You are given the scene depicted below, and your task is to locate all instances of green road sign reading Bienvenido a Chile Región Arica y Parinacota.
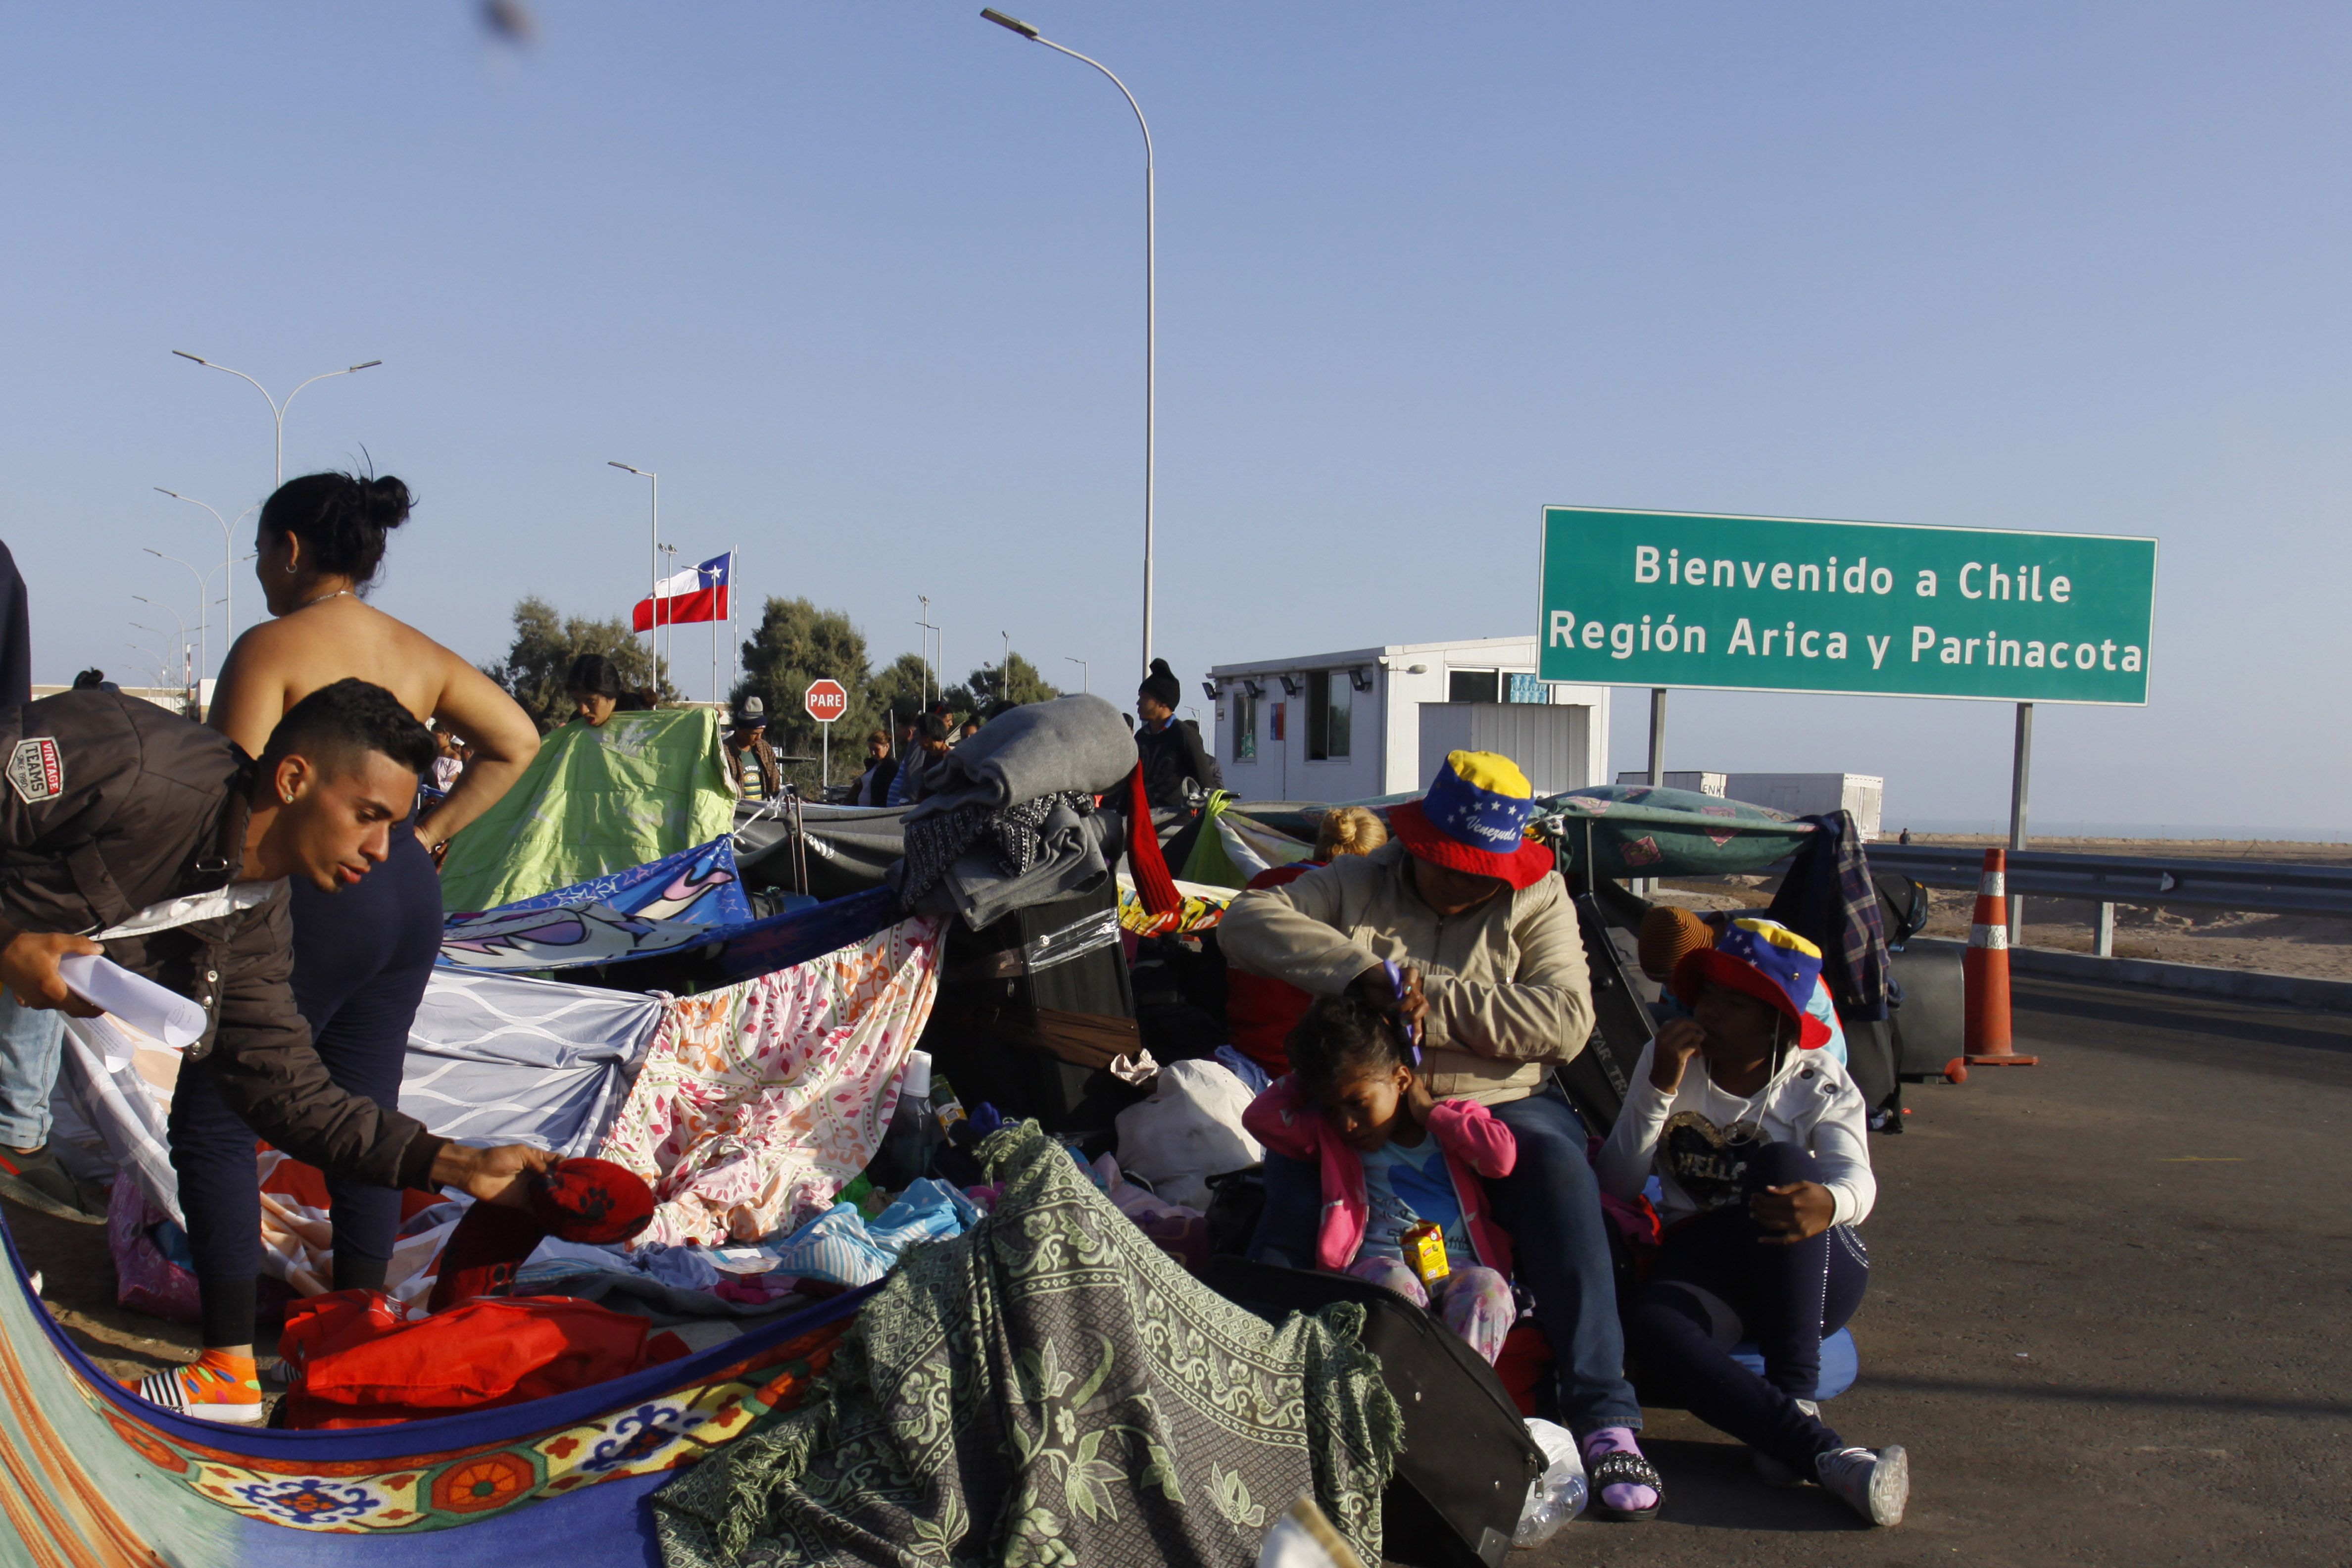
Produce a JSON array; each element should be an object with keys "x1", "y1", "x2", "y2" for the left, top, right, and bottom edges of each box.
[{"x1": 1541, "y1": 505, "x2": 2157, "y2": 705}]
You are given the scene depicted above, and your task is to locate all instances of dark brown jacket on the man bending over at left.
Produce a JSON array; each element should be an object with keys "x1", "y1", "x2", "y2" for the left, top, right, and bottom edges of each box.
[{"x1": 0, "y1": 691, "x2": 447, "y2": 1187}]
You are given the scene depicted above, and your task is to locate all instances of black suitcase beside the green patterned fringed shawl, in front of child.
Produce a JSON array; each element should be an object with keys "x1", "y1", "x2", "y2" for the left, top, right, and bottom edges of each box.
[{"x1": 1200, "y1": 1258, "x2": 1545, "y2": 1568}]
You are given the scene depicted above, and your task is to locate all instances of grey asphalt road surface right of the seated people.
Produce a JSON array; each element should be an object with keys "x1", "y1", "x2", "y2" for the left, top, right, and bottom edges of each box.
[{"x1": 1515, "y1": 978, "x2": 2352, "y2": 1568}]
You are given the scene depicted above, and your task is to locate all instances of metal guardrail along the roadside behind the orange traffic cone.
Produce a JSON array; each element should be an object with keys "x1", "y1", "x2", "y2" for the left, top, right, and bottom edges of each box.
[{"x1": 1867, "y1": 841, "x2": 2352, "y2": 919}]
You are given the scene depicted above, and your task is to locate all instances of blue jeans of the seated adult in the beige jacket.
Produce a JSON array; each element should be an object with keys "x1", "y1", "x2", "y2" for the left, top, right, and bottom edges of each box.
[{"x1": 1249, "y1": 1091, "x2": 1642, "y2": 1439}]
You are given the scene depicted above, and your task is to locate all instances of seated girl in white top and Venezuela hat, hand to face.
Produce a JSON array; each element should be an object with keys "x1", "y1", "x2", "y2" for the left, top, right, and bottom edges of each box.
[{"x1": 1599, "y1": 919, "x2": 1910, "y2": 1526}]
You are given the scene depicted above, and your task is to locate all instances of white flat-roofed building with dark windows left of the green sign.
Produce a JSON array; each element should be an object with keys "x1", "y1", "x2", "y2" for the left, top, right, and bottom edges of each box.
[{"x1": 1202, "y1": 637, "x2": 1609, "y2": 802}]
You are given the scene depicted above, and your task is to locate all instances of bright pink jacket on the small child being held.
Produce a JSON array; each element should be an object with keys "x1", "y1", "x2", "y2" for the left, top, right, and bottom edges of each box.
[{"x1": 1242, "y1": 1075, "x2": 1519, "y2": 1279}]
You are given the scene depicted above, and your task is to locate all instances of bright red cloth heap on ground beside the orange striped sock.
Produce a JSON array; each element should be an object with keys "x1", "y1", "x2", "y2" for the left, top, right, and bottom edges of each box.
[{"x1": 278, "y1": 1291, "x2": 687, "y2": 1429}]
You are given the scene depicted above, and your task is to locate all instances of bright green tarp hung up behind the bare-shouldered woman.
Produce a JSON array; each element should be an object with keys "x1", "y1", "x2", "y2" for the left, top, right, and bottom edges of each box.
[{"x1": 442, "y1": 708, "x2": 734, "y2": 912}]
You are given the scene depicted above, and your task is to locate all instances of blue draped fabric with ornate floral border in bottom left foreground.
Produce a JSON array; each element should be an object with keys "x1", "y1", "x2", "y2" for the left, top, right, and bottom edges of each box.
[{"x1": 0, "y1": 1232, "x2": 873, "y2": 1568}]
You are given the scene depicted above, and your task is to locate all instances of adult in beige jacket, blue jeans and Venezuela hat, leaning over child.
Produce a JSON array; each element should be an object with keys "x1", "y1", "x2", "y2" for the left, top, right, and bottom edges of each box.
[{"x1": 1219, "y1": 752, "x2": 1661, "y2": 1519}]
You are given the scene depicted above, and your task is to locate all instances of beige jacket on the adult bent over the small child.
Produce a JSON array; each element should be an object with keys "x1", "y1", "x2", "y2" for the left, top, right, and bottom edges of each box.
[{"x1": 1216, "y1": 841, "x2": 1592, "y2": 1105}]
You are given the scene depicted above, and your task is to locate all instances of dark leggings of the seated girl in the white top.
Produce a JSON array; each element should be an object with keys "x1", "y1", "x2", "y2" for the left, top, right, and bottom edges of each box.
[{"x1": 1625, "y1": 1142, "x2": 1870, "y2": 1476}]
